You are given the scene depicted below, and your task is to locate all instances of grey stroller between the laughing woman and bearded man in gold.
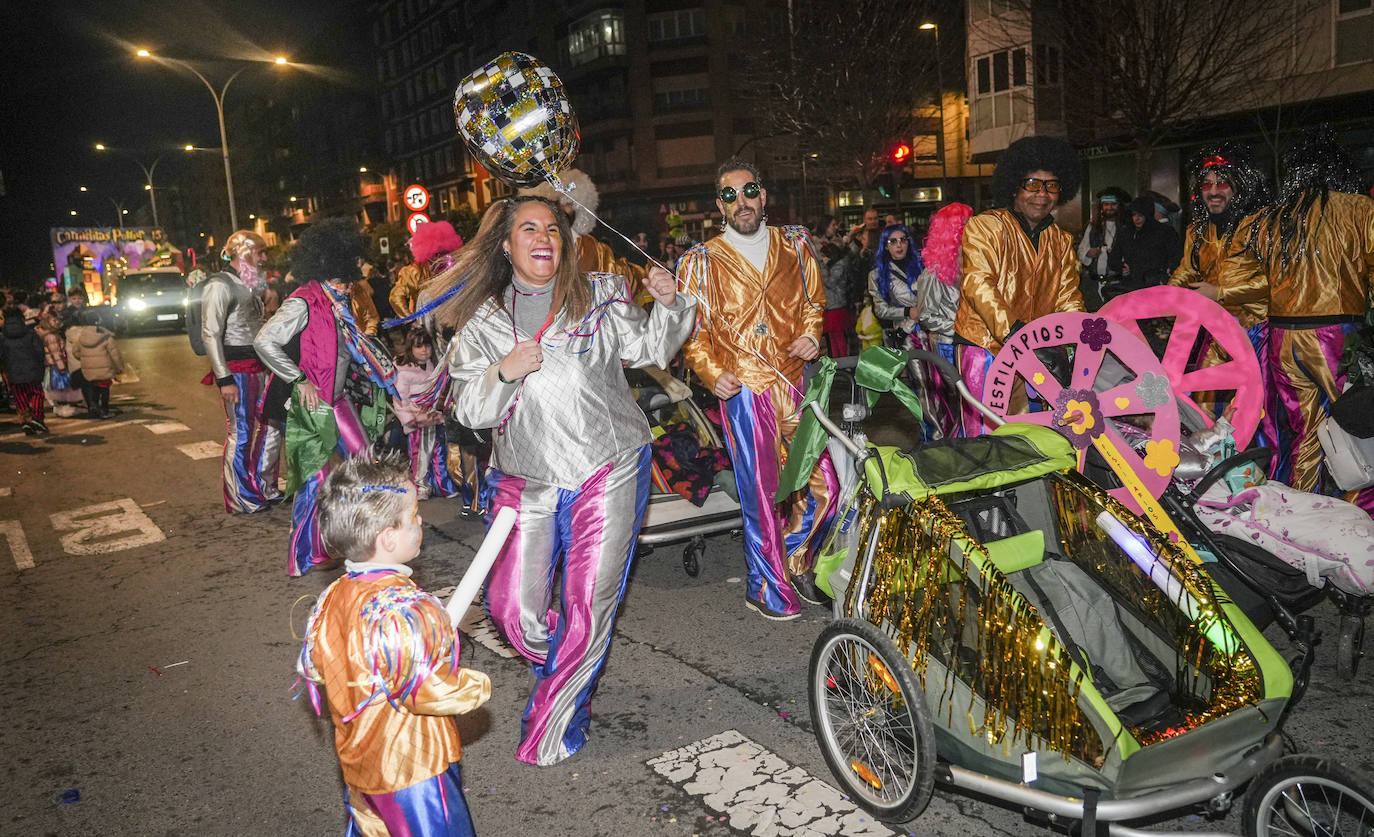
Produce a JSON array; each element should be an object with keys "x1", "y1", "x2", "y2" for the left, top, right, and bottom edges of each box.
[{"x1": 625, "y1": 368, "x2": 743, "y2": 577}]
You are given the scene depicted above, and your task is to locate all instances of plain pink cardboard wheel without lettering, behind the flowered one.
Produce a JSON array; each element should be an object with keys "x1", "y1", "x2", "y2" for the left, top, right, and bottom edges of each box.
[{"x1": 1098, "y1": 284, "x2": 1264, "y2": 451}]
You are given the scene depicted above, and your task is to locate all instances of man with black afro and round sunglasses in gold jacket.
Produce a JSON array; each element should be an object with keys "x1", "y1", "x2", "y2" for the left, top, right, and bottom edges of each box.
[{"x1": 954, "y1": 136, "x2": 1084, "y2": 436}]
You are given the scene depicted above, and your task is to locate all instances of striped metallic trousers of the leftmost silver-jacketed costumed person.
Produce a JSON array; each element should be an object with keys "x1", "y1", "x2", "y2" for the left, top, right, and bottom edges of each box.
[{"x1": 221, "y1": 372, "x2": 282, "y2": 514}]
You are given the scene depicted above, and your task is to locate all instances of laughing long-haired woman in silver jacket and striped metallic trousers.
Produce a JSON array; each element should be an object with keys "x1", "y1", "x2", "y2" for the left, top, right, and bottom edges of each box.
[{"x1": 433, "y1": 198, "x2": 697, "y2": 764}]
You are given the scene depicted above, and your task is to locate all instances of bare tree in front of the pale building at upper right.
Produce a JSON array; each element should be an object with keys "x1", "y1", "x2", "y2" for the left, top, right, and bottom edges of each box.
[{"x1": 1000, "y1": 0, "x2": 1330, "y2": 188}]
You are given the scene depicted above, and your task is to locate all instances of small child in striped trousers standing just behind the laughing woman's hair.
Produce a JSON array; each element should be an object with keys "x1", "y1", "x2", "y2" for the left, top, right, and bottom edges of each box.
[{"x1": 392, "y1": 328, "x2": 458, "y2": 500}]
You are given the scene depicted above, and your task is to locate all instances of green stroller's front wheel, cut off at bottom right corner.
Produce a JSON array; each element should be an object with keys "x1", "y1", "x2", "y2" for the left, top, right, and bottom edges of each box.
[{"x1": 1241, "y1": 756, "x2": 1374, "y2": 837}]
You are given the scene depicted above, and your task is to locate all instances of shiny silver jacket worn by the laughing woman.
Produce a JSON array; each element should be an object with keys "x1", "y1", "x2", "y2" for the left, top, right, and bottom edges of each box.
[{"x1": 448, "y1": 274, "x2": 697, "y2": 489}]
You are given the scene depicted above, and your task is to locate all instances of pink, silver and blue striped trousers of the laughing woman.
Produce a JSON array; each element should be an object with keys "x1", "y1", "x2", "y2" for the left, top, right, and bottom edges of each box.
[{"x1": 484, "y1": 445, "x2": 650, "y2": 766}]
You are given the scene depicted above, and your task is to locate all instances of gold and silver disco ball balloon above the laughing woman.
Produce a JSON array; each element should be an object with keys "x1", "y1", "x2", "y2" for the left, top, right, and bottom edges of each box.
[{"x1": 453, "y1": 52, "x2": 581, "y2": 186}]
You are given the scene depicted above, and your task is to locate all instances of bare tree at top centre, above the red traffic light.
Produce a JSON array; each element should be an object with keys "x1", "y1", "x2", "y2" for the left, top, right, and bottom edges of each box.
[{"x1": 739, "y1": 0, "x2": 962, "y2": 184}]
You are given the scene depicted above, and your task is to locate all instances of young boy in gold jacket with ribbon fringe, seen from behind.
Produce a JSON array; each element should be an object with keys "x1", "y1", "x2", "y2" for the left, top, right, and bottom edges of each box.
[{"x1": 297, "y1": 456, "x2": 492, "y2": 837}]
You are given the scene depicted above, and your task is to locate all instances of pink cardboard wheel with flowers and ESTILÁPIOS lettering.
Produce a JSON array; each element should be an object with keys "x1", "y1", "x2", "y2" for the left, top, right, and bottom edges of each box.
[{"x1": 984, "y1": 312, "x2": 1179, "y2": 513}]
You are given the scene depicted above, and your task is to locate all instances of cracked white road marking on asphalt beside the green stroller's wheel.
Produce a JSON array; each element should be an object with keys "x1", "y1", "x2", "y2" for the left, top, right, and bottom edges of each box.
[{"x1": 646, "y1": 730, "x2": 899, "y2": 837}]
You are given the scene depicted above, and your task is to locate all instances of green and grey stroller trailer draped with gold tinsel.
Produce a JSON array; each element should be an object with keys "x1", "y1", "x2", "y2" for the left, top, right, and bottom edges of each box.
[{"x1": 807, "y1": 349, "x2": 1374, "y2": 836}]
